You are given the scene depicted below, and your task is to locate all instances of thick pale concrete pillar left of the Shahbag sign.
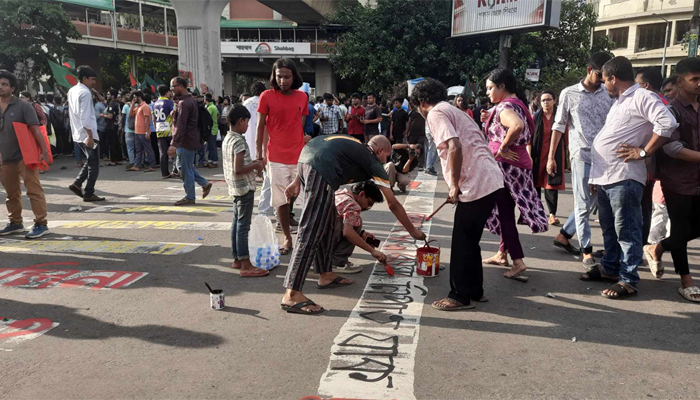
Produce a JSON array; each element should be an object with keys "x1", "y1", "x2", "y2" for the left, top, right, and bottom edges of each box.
[{"x1": 170, "y1": 0, "x2": 229, "y2": 96}]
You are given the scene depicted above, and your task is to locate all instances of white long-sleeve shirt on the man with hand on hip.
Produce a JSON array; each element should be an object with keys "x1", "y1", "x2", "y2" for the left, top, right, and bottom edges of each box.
[{"x1": 588, "y1": 84, "x2": 678, "y2": 185}]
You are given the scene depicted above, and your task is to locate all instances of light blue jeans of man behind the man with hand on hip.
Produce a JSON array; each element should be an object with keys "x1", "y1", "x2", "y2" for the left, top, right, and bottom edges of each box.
[{"x1": 557, "y1": 159, "x2": 598, "y2": 254}]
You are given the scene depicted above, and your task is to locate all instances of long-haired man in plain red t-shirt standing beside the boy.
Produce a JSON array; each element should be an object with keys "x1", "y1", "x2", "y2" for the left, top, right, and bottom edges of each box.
[{"x1": 256, "y1": 58, "x2": 311, "y2": 255}]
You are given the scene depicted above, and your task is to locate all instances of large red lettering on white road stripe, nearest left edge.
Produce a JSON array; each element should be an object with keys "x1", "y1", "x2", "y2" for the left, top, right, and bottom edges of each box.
[{"x1": 0, "y1": 261, "x2": 148, "y2": 289}]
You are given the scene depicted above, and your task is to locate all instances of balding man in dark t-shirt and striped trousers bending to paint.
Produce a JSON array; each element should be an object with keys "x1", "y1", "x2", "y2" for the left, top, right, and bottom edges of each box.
[{"x1": 282, "y1": 135, "x2": 426, "y2": 314}]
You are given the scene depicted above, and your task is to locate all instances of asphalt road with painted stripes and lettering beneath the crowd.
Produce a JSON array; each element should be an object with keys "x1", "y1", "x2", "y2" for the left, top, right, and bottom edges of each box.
[{"x1": 0, "y1": 155, "x2": 700, "y2": 400}]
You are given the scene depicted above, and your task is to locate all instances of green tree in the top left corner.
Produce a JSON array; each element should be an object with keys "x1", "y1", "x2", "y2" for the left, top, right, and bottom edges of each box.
[{"x1": 0, "y1": 0, "x2": 81, "y2": 88}]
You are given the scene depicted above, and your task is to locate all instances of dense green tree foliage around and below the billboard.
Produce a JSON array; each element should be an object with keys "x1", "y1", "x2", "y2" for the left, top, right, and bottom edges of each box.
[{"x1": 329, "y1": 0, "x2": 607, "y2": 96}]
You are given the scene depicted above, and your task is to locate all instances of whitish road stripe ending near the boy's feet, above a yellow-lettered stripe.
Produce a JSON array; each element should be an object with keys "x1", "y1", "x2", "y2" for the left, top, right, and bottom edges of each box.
[{"x1": 49, "y1": 220, "x2": 231, "y2": 231}]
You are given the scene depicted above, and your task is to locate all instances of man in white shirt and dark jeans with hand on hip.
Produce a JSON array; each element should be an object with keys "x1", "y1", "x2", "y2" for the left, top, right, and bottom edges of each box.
[{"x1": 581, "y1": 57, "x2": 678, "y2": 299}]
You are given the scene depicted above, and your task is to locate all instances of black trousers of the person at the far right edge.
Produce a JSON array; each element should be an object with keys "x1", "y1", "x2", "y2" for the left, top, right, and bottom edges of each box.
[{"x1": 661, "y1": 188, "x2": 700, "y2": 275}]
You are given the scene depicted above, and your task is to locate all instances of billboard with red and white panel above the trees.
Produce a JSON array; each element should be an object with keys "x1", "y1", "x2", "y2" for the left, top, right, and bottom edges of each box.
[{"x1": 452, "y1": 0, "x2": 561, "y2": 36}]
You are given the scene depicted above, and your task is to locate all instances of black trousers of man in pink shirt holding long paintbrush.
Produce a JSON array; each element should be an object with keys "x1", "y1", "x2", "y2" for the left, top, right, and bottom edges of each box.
[{"x1": 448, "y1": 191, "x2": 498, "y2": 304}]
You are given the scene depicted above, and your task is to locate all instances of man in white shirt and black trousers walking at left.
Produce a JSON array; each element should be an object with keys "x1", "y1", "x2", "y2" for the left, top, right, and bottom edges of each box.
[{"x1": 68, "y1": 65, "x2": 104, "y2": 202}]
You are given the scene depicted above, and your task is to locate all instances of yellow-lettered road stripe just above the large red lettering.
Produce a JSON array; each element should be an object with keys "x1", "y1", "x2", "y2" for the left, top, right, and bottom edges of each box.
[{"x1": 0, "y1": 239, "x2": 200, "y2": 256}]
